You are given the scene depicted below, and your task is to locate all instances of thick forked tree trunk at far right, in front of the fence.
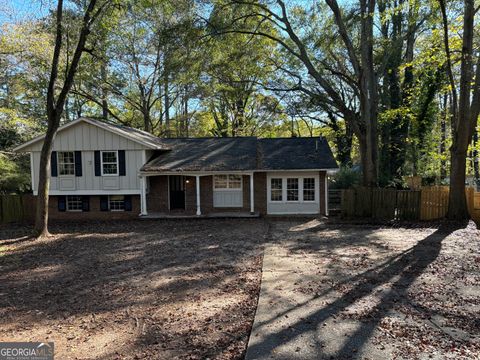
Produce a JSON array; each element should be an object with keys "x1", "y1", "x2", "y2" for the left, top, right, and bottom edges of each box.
[{"x1": 439, "y1": 0, "x2": 480, "y2": 220}]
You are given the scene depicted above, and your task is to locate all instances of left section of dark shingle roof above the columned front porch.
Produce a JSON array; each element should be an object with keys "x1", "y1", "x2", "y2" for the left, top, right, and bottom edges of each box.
[{"x1": 141, "y1": 137, "x2": 257, "y2": 172}]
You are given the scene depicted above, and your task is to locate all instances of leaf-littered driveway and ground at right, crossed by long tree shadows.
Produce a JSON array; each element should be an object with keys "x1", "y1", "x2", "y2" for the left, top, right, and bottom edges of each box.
[{"x1": 249, "y1": 220, "x2": 480, "y2": 360}]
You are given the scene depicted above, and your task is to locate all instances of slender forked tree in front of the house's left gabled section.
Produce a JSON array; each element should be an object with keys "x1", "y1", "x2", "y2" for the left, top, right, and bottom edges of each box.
[{"x1": 34, "y1": 0, "x2": 110, "y2": 238}]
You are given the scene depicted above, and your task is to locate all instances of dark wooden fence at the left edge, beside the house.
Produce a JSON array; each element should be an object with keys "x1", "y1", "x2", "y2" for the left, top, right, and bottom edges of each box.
[{"x1": 0, "y1": 195, "x2": 35, "y2": 224}]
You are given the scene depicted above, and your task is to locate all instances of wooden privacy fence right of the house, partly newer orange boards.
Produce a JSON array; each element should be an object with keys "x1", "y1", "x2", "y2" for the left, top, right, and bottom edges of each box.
[{"x1": 342, "y1": 186, "x2": 480, "y2": 221}]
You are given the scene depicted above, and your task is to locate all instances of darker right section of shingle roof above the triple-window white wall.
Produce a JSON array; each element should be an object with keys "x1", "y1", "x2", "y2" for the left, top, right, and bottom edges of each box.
[{"x1": 258, "y1": 137, "x2": 338, "y2": 170}]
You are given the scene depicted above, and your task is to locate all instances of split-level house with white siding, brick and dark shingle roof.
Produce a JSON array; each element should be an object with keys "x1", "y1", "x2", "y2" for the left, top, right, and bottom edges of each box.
[{"x1": 15, "y1": 118, "x2": 337, "y2": 219}]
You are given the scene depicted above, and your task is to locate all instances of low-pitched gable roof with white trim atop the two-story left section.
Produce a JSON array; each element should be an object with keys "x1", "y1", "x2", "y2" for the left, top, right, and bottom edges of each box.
[{"x1": 13, "y1": 117, "x2": 168, "y2": 151}]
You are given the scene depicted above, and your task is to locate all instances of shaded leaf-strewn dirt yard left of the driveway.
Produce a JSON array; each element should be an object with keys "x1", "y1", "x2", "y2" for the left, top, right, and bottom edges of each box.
[{"x1": 0, "y1": 220, "x2": 267, "y2": 359}]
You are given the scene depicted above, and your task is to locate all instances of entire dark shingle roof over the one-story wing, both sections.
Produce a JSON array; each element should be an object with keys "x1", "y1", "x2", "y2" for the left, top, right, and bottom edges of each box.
[{"x1": 140, "y1": 137, "x2": 337, "y2": 173}]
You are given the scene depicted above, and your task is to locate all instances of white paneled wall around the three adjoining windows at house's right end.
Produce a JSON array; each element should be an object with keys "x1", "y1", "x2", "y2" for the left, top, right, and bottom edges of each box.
[{"x1": 267, "y1": 172, "x2": 320, "y2": 215}]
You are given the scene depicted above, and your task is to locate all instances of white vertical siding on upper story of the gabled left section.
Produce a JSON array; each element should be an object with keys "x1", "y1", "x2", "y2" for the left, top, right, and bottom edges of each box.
[{"x1": 31, "y1": 122, "x2": 146, "y2": 195}]
